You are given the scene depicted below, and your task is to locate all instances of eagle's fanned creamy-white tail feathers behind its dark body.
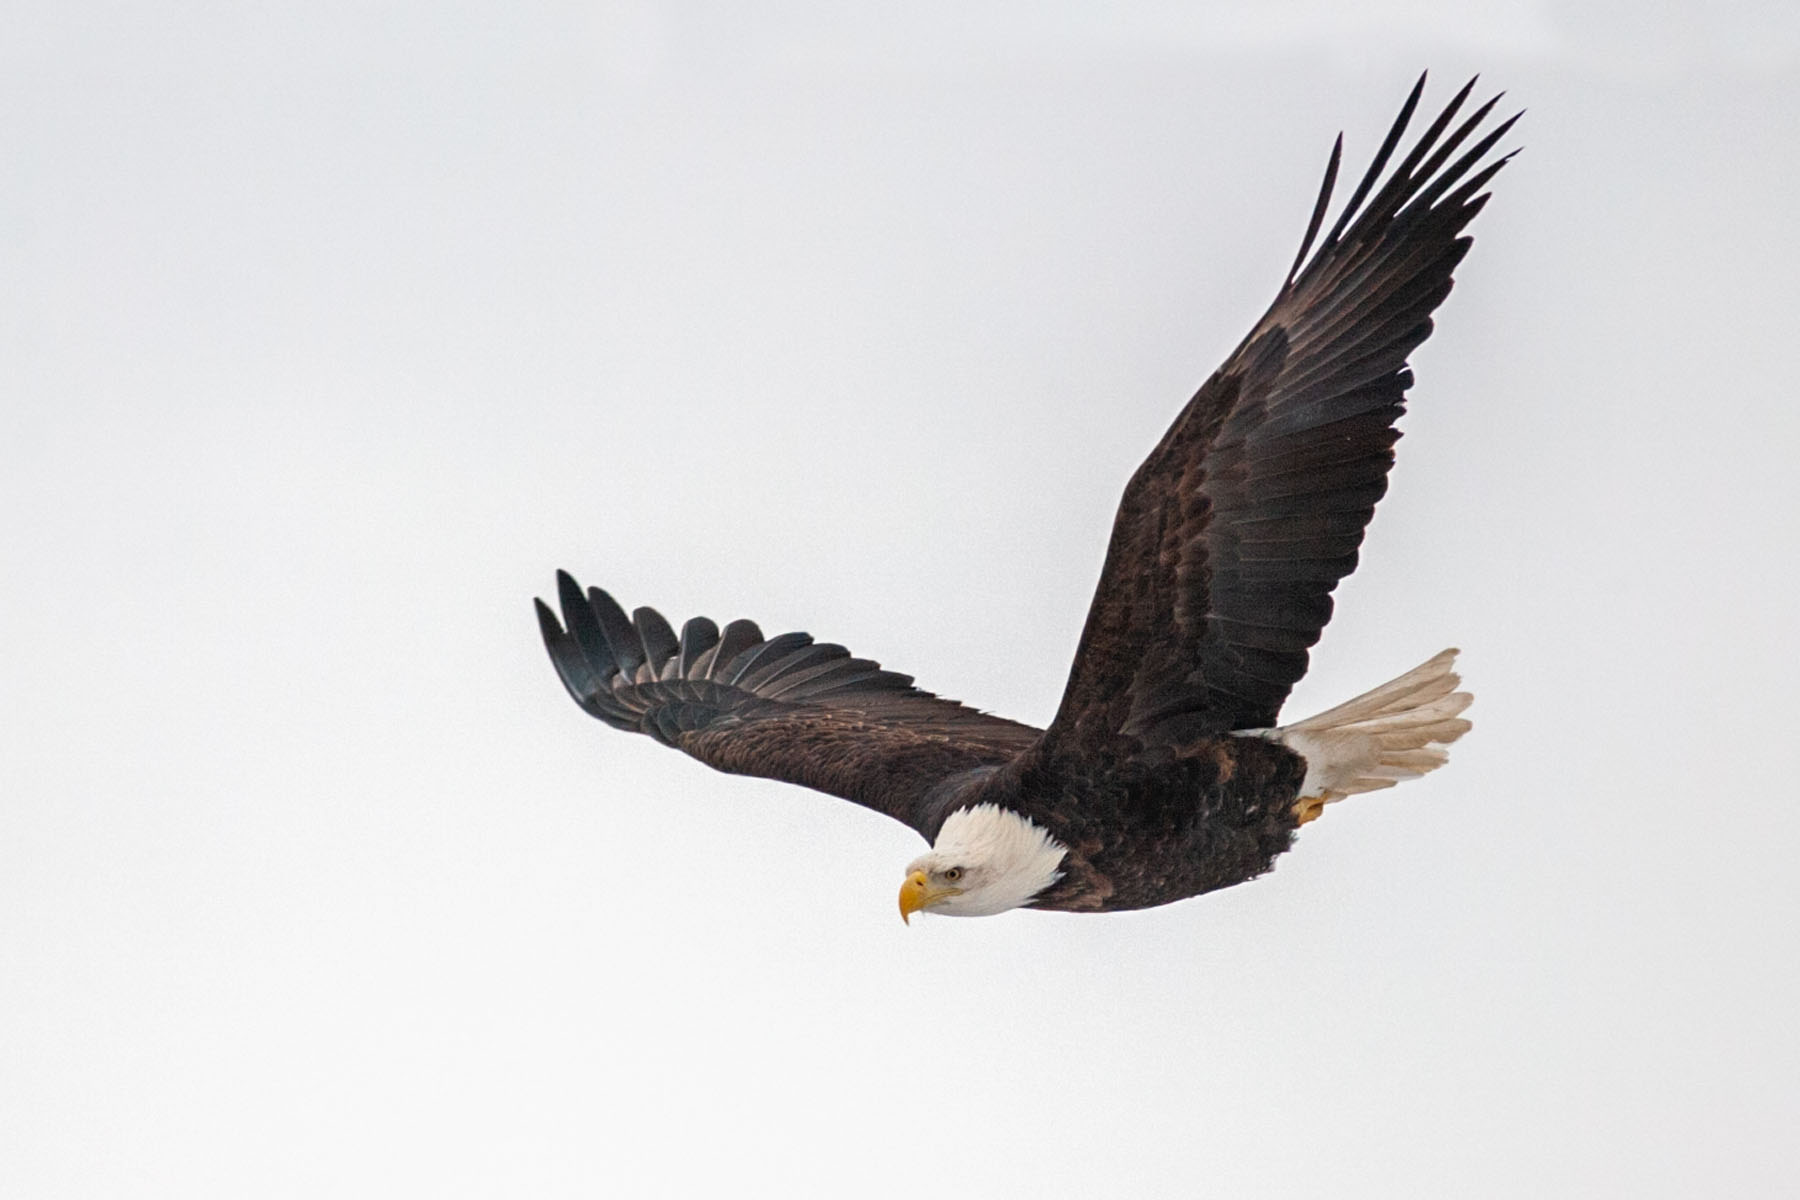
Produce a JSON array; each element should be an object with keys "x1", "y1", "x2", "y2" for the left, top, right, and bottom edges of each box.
[{"x1": 1264, "y1": 649, "x2": 1474, "y2": 820}]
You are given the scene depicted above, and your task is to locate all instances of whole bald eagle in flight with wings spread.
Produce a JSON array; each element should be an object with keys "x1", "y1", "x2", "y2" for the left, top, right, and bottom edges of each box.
[{"x1": 536, "y1": 77, "x2": 1517, "y2": 919}]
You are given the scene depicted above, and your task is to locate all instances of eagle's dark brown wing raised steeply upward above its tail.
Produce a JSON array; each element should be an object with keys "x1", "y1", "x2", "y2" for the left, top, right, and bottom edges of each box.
[{"x1": 1046, "y1": 77, "x2": 1517, "y2": 750}]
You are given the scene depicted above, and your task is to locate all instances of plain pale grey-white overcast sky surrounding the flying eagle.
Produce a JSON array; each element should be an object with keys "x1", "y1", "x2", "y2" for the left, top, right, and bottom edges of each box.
[{"x1": 0, "y1": 0, "x2": 1800, "y2": 1200}]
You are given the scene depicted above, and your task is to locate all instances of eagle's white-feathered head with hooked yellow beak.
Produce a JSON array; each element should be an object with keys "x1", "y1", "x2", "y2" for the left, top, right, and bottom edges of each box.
[{"x1": 900, "y1": 804, "x2": 1069, "y2": 925}]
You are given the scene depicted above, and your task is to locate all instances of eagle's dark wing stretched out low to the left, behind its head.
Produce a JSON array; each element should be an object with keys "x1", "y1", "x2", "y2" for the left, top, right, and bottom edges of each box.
[{"x1": 536, "y1": 572, "x2": 1040, "y2": 838}]
